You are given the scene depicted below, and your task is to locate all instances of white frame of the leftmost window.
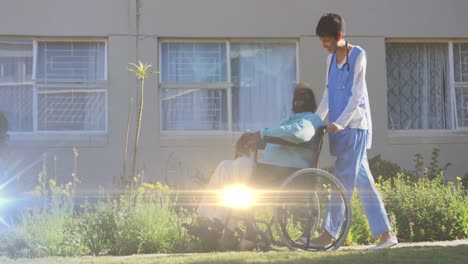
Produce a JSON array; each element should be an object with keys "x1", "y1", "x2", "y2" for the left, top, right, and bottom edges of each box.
[{"x1": 2, "y1": 37, "x2": 109, "y2": 136}]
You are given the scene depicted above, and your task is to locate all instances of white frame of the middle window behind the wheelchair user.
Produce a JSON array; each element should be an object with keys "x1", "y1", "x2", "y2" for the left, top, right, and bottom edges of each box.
[{"x1": 158, "y1": 38, "x2": 300, "y2": 136}]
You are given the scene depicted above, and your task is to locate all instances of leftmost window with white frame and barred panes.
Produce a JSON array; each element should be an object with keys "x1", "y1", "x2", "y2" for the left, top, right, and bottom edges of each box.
[{"x1": 0, "y1": 40, "x2": 107, "y2": 133}]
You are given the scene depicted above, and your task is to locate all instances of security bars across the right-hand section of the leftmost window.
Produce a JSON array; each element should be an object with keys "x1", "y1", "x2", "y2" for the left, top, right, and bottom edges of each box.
[{"x1": 36, "y1": 41, "x2": 106, "y2": 132}]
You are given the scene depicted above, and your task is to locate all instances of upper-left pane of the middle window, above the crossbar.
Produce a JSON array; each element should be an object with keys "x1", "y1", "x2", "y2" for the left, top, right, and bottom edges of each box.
[{"x1": 161, "y1": 42, "x2": 227, "y2": 83}]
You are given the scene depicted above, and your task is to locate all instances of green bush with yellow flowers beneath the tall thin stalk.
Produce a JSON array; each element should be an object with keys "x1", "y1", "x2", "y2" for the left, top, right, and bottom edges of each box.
[{"x1": 77, "y1": 183, "x2": 189, "y2": 255}]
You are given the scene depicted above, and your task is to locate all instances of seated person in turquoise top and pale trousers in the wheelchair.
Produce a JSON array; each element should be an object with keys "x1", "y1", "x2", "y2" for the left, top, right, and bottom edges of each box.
[{"x1": 184, "y1": 83, "x2": 325, "y2": 249}]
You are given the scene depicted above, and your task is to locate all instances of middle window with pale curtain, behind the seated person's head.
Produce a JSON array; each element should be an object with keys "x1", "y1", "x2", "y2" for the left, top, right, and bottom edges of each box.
[{"x1": 160, "y1": 40, "x2": 298, "y2": 131}]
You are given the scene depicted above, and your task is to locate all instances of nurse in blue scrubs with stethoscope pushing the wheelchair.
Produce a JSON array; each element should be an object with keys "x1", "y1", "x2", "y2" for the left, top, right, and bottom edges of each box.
[{"x1": 312, "y1": 14, "x2": 398, "y2": 249}]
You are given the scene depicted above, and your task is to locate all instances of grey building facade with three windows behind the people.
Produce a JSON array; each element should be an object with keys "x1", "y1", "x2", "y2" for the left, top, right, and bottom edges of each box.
[{"x1": 0, "y1": 0, "x2": 468, "y2": 190}]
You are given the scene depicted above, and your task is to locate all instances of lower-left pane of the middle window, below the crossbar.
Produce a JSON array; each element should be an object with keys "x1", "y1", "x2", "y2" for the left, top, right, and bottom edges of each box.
[{"x1": 161, "y1": 89, "x2": 227, "y2": 131}]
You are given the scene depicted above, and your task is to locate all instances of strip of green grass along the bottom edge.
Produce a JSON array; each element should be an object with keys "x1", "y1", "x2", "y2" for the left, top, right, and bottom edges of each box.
[{"x1": 0, "y1": 245, "x2": 468, "y2": 264}]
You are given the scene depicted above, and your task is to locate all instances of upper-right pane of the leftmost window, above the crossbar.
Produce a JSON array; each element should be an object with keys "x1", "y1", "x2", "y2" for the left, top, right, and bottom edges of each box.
[{"x1": 36, "y1": 41, "x2": 106, "y2": 80}]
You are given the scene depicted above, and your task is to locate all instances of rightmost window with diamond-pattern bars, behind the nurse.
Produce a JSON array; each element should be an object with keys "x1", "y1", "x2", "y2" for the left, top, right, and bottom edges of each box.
[{"x1": 386, "y1": 42, "x2": 468, "y2": 130}]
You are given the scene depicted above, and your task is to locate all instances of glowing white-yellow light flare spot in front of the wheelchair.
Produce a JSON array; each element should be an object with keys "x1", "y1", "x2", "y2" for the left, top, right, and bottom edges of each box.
[{"x1": 221, "y1": 185, "x2": 255, "y2": 208}]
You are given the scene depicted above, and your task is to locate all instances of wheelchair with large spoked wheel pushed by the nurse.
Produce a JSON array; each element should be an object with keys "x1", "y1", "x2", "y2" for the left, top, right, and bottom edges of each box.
[{"x1": 222, "y1": 127, "x2": 351, "y2": 251}]
